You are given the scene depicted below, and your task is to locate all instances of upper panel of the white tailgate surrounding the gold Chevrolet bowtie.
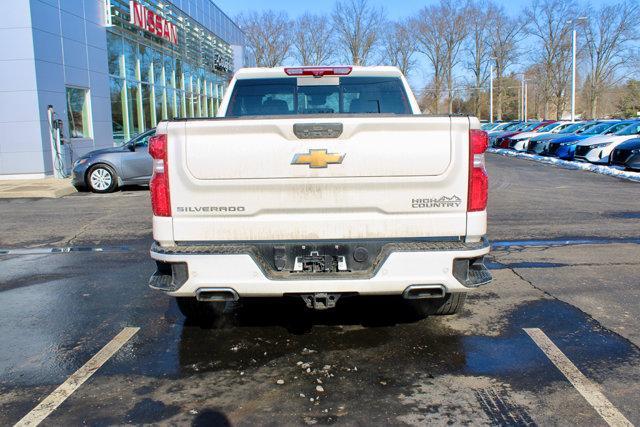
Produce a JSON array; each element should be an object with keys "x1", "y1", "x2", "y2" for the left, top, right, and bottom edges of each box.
[{"x1": 184, "y1": 117, "x2": 452, "y2": 180}]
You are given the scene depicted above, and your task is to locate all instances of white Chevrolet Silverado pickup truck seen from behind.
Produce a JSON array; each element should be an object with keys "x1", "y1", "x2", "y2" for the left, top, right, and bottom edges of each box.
[{"x1": 149, "y1": 67, "x2": 491, "y2": 320}]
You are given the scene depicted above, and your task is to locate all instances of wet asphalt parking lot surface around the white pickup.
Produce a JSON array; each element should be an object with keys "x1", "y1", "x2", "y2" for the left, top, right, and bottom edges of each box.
[{"x1": 0, "y1": 155, "x2": 640, "y2": 425}]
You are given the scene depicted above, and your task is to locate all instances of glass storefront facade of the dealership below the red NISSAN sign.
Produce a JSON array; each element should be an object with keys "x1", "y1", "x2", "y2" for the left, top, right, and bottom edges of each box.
[{"x1": 104, "y1": 0, "x2": 233, "y2": 141}]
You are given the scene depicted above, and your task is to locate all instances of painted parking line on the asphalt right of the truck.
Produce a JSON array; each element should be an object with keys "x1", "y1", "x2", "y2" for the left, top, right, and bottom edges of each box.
[{"x1": 524, "y1": 328, "x2": 633, "y2": 427}]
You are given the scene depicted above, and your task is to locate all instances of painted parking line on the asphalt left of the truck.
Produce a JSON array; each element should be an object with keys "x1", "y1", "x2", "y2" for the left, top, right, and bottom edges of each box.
[{"x1": 16, "y1": 328, "x2": 140, "y2": 426}]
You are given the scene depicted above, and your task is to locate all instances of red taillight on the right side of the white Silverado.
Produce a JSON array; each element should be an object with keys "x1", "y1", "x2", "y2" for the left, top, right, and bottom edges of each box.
[{"x1": 467, "y1": 129, "x2": 489, "y2": 212}]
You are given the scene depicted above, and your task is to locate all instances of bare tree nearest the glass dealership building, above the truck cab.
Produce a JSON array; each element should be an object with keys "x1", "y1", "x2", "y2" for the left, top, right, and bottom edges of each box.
[{"x1": 237, "y1": 10, "x2": 292, "y2": 67}]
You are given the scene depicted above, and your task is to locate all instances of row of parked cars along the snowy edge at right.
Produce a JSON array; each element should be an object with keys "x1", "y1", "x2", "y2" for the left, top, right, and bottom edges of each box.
[{"x1": 483, "y1": 120, "x2": 640, "y2": 171}]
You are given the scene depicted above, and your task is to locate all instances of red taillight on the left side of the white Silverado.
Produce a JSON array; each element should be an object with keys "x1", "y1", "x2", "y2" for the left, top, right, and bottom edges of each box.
[{"x1": 149, "y1": 135, "x2": 171, "y2": 216}]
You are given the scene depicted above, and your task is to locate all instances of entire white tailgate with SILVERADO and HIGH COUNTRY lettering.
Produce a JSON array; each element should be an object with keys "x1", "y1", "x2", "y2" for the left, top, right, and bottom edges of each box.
[{"x1": 167, "y1": 115, "x2": 470, "y2": 241}]
